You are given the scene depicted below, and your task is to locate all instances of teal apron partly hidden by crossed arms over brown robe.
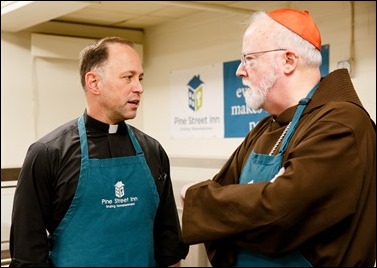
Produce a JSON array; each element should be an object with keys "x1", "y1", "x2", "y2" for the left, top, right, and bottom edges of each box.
[{"x1": 234, "y1": 86, "x2": 318, "y2": 267}]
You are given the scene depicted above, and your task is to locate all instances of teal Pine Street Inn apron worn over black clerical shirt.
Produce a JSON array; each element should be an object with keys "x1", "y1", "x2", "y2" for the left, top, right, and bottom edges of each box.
[{"x1": 50, "y1": 116, "x2": 159, "y2": 267}]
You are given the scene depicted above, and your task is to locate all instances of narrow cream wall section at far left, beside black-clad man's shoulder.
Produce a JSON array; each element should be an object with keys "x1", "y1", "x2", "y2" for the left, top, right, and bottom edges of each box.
[{"x1": 1, "y1": 32, "x2": 35, "y2": 168}]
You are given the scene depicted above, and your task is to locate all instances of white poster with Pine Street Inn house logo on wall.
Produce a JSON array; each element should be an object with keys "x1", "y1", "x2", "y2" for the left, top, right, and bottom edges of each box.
[{"x1": 170, "y1": 63, "x2": 224, "y2": 139}]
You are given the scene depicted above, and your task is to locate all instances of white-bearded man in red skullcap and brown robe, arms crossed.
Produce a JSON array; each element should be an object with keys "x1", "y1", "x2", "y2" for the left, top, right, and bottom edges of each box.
[{"x1": 181, "y1": 9, "x2": 376, "y2": 267}]
